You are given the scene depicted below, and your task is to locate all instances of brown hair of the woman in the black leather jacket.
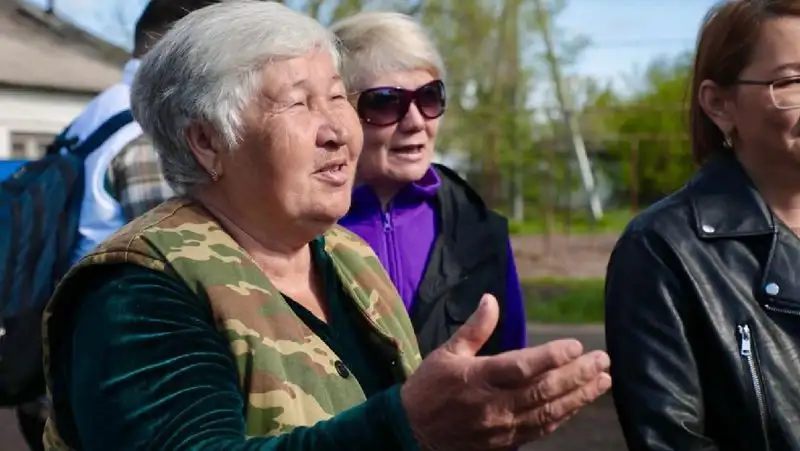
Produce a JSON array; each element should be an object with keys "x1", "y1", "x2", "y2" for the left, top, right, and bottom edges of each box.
[{"x1": 689, "y1": 0, "x2": 800, "y2": 164}]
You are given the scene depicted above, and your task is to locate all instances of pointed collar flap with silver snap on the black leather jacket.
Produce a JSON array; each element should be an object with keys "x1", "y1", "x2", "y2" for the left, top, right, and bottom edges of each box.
[{"x1": 688, "y1": 155, "x2": 776, "y2": 239}]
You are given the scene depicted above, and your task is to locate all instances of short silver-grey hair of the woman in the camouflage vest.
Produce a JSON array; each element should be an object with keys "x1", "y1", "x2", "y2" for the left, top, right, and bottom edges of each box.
[{"x1": 131, "y1": 0, "x2": 341, "y2": 193}]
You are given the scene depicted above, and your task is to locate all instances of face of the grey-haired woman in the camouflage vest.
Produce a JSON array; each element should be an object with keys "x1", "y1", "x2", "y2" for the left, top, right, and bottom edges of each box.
[{"x1": 218, "y1": 52, "x2": 363, "y2": 228}]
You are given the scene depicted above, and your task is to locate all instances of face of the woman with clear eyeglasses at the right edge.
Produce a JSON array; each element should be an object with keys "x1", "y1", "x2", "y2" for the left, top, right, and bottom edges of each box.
[{"x1": 707, "y1": 17, "x2": 800, "y2": 167}]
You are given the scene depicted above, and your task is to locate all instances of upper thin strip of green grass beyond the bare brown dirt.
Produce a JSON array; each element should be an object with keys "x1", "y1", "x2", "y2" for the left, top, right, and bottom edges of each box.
[{"x1": 508, "y1": 210, "x2": 634, "y2": 235}]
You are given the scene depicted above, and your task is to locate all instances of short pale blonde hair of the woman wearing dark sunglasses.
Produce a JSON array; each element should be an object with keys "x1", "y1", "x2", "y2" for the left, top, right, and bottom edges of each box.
[{"x1": 331, "y1": 12, "x2": 445, "y2": 91}]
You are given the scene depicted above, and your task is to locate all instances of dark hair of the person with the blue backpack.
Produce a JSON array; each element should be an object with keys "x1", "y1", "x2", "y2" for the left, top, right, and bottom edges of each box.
[{"x1": 133, "y1": 0, "x2": 221, "y2": 54}]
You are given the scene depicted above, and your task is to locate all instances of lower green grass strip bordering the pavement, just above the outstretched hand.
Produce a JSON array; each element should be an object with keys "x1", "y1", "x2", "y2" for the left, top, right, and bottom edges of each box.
[{"x1": 522, "y1": 279, "x2": 603, "y2": 324}]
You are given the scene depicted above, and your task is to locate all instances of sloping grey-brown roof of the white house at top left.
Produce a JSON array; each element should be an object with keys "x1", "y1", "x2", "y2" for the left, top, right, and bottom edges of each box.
[{"x1": 0, "y1": 0, "x2": 129, "y2": 94}]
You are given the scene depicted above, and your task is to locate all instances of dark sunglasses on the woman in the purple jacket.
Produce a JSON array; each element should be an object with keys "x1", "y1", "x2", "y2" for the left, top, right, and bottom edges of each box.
[{"x1": 356, "y1": 80, "x2": 447, "y2": 127}]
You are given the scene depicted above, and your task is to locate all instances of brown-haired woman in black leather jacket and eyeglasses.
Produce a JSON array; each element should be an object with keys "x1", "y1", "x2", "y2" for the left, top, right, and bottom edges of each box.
[{"x1": 606, "y1": 0, "x2": 800, "y2": 451}]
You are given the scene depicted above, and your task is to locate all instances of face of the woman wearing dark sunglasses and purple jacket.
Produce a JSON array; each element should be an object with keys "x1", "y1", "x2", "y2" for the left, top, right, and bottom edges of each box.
[{"x1": 357, "y1": 70, "x2": 445, "y2": 190}]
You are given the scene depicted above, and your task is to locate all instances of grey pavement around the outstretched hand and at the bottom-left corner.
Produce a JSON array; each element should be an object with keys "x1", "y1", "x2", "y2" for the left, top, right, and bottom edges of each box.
[{"x1": 0, "y1": 325, "x2": 625, "y2": 451}]
